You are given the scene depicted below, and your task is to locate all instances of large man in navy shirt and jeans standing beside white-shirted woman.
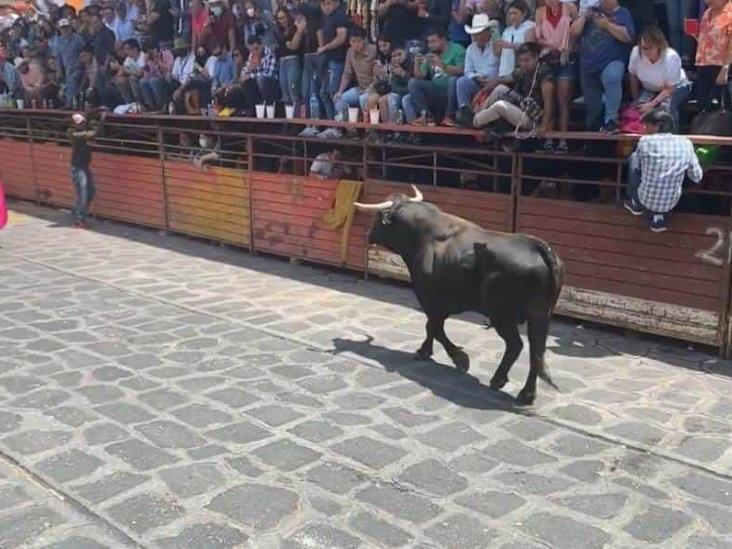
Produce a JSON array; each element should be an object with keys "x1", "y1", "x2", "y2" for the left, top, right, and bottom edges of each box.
[{"x1": 572, "y1": 0, "x2": 635, "y2": 133}]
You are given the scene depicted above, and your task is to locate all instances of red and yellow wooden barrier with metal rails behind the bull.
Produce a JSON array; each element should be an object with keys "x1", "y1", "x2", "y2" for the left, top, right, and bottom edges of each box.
[{"x1": 0, "y1": 111, "x2": 732, "y2": 353}]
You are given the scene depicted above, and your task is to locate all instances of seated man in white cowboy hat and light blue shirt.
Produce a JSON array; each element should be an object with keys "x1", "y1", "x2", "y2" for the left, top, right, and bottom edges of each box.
[{"x1": 443, "y1": 13, "x2": 498, "y2": 126}]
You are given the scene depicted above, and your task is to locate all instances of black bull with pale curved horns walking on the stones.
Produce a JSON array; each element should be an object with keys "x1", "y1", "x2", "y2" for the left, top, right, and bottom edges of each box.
[{"x1": 356, "y1": 186, "x2": 564, "y2": 405}]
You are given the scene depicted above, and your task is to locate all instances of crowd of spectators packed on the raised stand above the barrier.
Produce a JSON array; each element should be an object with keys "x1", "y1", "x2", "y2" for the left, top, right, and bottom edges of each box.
[{"x1": 0, "y1": 0, "x2": 732, "y2": 148}]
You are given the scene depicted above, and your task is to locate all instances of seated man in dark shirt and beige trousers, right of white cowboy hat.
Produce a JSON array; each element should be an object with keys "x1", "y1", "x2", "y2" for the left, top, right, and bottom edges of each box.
[{"x1": 473, "y1": 43, "x2": 554, "y2": 132}]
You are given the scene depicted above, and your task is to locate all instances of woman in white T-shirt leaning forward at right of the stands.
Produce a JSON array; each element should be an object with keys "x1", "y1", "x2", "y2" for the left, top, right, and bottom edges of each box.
[{"x1": 628, "y1": 27, "x2": 691, "y2": 128}]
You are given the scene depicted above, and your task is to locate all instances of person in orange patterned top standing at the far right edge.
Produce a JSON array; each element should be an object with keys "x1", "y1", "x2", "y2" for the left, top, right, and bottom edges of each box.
[{"x1": 694, "y1": 0, "x2": 732, "y2": 111}]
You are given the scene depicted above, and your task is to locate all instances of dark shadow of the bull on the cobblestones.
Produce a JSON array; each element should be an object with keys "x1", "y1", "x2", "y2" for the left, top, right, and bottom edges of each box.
[{"x1": 330, "y1": 336, "x2": 528, "y2": 412}]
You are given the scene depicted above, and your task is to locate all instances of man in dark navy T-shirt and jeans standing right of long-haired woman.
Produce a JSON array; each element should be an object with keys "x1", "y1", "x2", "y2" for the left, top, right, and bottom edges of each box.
[{"x1": 318, "y1": 0, "x2": 349, "y2": 120}]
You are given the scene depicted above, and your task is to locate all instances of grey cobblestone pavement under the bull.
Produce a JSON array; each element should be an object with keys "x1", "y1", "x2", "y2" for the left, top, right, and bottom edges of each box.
[{"x1": 0, "y1": 204, "x2": 732, "y2": 549}]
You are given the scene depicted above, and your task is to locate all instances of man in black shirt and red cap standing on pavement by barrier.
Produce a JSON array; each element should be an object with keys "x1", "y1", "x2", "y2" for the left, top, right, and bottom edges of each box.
[{"x1": 67, "y1": 112, "x2": 107, "y2": 229}]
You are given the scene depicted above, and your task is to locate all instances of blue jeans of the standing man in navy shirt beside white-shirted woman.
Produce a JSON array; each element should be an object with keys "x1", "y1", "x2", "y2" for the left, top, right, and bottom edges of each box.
[{"x1": 580, "y1": 61, "x2": 625, "y2": 131}]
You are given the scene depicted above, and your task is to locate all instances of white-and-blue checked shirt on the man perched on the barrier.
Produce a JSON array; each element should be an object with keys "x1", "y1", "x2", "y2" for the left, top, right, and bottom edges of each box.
[{"x1": 634, "y1": 133, "x2": 703, "y2": 213}]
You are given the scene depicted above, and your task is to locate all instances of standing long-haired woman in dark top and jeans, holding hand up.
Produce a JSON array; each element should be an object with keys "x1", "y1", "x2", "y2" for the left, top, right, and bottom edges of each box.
[{"x1": 275, "y1": 8, "x2": 307, "y2": 116}]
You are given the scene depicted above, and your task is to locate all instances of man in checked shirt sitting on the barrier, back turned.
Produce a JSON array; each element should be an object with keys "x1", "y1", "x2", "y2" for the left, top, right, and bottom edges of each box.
[{"x1": 625, "y1": 107, "x2": 703, "y2": 232}]
